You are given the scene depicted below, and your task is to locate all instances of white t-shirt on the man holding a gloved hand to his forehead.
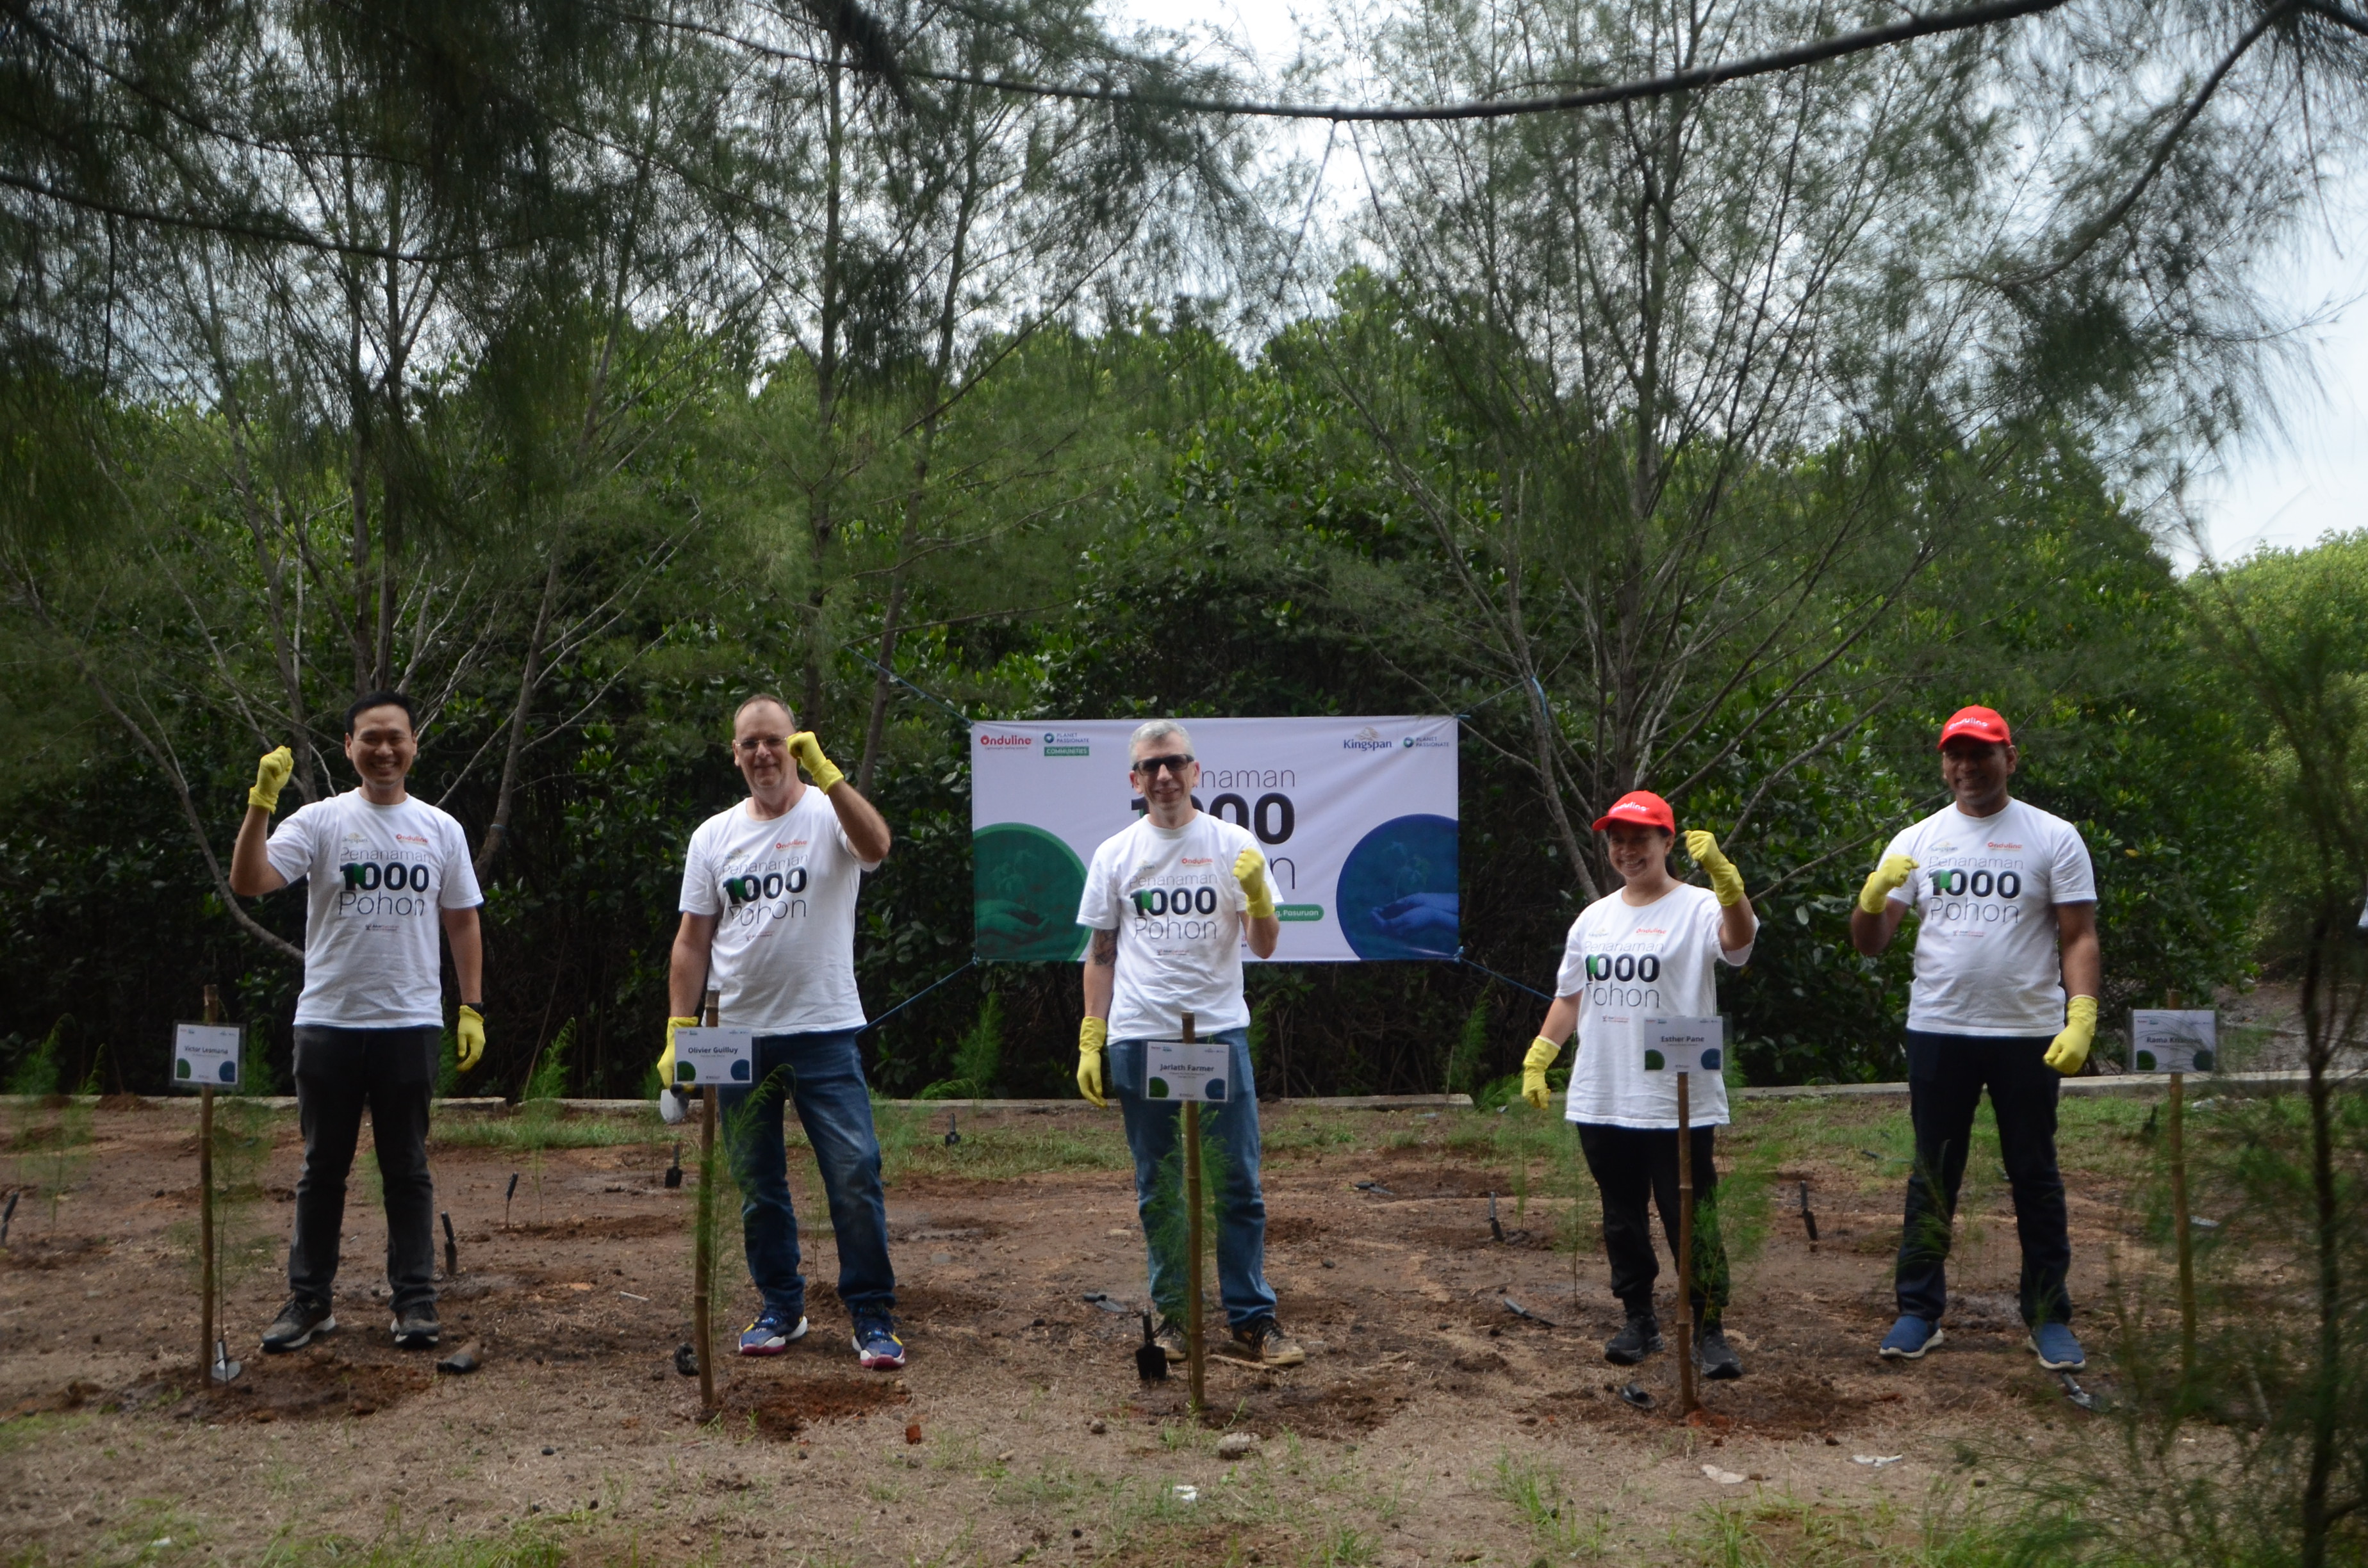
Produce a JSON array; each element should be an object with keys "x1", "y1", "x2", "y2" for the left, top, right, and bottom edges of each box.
[{"x1": 682, "y1": 784, "x2": 878, "y2": 1035}]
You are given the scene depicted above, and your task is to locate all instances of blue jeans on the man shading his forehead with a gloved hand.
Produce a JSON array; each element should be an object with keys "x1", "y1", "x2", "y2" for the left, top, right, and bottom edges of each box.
[{"x1": 715, "y1": 1031, "x2": 895, "y2": 1321}]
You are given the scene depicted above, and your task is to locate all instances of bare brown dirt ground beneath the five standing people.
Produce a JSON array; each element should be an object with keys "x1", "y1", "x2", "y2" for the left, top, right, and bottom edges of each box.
[{"x1": 0, "y1": 1102, "x2": 2146, "y2": 1564}]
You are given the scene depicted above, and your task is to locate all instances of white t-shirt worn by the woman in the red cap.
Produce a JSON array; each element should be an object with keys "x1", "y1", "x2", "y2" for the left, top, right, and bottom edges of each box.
[{"x1": 1554, "y1": 883, "x2": 1752, "y2": 1127}]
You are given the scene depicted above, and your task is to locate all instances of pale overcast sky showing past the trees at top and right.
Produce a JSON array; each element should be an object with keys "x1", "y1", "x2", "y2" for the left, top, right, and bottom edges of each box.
[{"x1": 1113, "y1": 0, "x2": 2368, "y2": 561}]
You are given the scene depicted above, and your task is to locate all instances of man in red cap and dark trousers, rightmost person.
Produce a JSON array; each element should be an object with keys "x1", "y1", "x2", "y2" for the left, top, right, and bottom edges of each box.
[{"x1": 1850, "y1": 708, "x2": 2103, "y2": 1371}]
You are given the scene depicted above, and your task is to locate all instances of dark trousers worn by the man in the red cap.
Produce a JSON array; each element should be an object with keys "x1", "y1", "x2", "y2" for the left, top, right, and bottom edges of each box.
[{"x1": 1896, "y1": 1028, "x2": 2072, "y2": 1324}]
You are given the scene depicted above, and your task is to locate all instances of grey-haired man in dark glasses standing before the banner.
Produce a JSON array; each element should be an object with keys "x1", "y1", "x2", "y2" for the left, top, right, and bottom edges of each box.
[{"x1": 1078, "y1": 717, "x2": 1307, "y2": 1367}]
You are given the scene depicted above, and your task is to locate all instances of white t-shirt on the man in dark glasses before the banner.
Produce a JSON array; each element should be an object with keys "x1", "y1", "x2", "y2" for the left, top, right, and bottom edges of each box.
[{"x1": 1078, "y1": 812, "x2": 1258, "y2": 1040}]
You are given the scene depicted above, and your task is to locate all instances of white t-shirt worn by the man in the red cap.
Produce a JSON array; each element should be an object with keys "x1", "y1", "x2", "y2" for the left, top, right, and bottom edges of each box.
[{"x1": 1882, "y1": 801, "x2": 2096, "y2": 1035}]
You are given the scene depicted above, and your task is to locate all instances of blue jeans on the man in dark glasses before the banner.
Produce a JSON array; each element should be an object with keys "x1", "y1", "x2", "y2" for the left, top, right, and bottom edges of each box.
[{"x1": 1110, "y1": 1028, "x2": 1274, "y2": 1329}]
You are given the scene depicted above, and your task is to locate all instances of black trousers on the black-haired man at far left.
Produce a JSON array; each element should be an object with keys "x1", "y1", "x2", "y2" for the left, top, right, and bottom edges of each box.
[{"x1": 289, "y1": 1023, "x2": 443, "y2": 1317}]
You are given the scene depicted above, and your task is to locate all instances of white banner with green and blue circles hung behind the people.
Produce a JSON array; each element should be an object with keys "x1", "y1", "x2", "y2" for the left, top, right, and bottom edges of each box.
[{"x1": 971, "y1": 717, "x2": 1459, "y2": 964}]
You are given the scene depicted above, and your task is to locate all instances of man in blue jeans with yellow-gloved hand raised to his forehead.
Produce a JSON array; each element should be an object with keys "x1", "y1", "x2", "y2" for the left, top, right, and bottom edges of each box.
[{"x1": 658, "y1": 694, "x2": 905, "y2": 1371}]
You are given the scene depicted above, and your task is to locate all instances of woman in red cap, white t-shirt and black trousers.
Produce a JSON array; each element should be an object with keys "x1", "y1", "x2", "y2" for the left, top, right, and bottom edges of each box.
[{"x1": 1520, "y1": 788, "x2": 1759, "y2": 1378}]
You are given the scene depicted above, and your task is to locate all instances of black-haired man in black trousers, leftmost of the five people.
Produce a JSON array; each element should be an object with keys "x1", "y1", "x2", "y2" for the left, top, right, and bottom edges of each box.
[{"x1": 230, "y1": 692, "x2": 486, "y2": 1350}]
